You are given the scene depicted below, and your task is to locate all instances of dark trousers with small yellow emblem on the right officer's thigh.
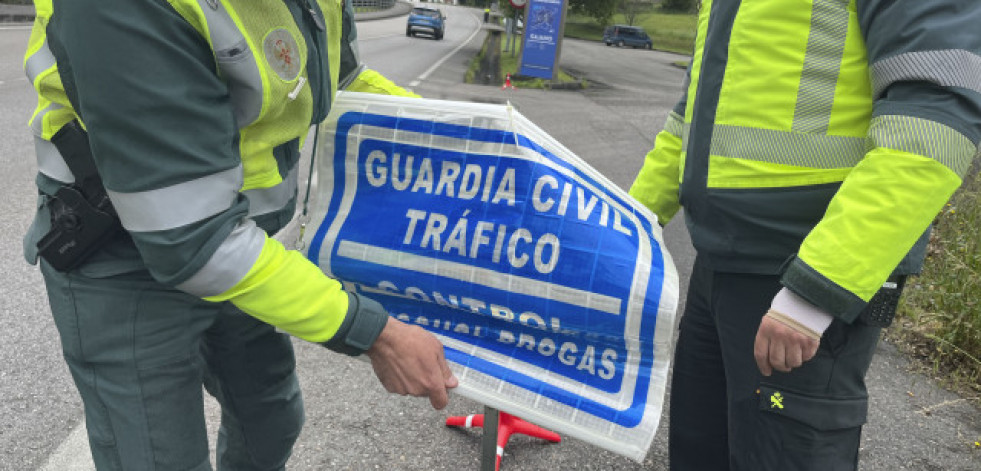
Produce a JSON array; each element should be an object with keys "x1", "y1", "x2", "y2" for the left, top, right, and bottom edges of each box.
[{"x1": 668, "y1": 257, "x2": 881, "y2": 471}]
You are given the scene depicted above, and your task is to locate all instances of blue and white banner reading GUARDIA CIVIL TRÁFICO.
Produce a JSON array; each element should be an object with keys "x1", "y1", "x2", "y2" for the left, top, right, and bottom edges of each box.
[{"x1": 304, "y1": 92, "x2": 678, "y2": 461}]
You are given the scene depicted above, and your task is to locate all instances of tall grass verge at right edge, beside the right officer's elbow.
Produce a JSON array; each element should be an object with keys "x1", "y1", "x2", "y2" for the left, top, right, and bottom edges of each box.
[{"x1": 887, "y1": 167, "x2": 981, "y2": 405}]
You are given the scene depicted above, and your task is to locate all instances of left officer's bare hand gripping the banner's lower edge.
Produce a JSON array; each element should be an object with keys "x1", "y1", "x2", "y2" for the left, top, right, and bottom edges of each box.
[{"x1": 366, "y1": 318, "x2": 458, "y2": 409}]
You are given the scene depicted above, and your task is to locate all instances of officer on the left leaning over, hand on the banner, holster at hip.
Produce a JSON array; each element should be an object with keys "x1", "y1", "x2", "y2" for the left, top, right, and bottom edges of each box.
[{"x1": 25, "y1": 0, "x2": 457, "y2": 470}]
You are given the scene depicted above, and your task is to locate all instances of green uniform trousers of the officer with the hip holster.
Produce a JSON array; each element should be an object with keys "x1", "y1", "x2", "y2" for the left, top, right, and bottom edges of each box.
[{"x1": 41, "y1": 251, "x2": 303, "y2": 471}]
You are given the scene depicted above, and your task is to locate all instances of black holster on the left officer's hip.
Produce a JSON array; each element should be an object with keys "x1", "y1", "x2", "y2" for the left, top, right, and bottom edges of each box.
[{"x1": 37, "y1": 121, "x2": 122, "y2": 272}]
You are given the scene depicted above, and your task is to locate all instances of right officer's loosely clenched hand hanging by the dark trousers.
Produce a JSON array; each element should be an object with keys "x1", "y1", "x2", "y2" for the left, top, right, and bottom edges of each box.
[{"x1": 753, "y1": 311, "x2": 820, "y2": 376}]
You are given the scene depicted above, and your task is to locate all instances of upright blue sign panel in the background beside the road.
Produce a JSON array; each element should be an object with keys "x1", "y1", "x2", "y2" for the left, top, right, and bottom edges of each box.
[{"x1": 518, "y1": 0, "x2": 563, "y2": 79}]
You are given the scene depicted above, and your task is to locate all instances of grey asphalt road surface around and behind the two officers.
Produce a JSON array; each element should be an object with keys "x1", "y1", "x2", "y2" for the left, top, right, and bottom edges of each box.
[{"x1": 0, "y1": 7, "x2": 981, "y2": 471}]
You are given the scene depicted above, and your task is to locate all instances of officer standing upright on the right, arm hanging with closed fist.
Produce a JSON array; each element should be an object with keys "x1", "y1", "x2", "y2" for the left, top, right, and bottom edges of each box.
[{"x1": 630, "y1": 0, "x2": 981, "y2": 471}]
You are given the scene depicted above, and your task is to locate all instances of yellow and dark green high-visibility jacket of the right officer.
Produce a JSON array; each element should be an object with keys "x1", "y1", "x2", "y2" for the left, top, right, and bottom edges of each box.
[{"x1": 630, "y1": 0, "x2": 981, "y2": 322}]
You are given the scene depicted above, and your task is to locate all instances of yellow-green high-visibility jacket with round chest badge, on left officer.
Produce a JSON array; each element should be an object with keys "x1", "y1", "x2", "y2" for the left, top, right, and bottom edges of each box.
[{"x1": 24, "y1": 0, "x2": 408, "y2": 342}]
